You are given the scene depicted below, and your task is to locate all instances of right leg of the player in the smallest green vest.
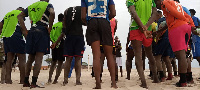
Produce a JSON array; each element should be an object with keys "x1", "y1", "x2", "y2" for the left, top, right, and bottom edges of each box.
[{"x1": 52, "y1": 60, "x2": 63, "y2": 84}]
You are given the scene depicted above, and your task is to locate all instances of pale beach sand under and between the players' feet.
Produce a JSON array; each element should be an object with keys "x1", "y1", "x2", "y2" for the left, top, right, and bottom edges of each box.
[{"x1": 0, "y1": 68, "x2": 200, "y2": 90}]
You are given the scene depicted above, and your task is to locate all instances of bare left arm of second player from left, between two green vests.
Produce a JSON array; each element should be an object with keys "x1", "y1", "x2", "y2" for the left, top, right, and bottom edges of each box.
[{"x1": 17, "y1": 12, "x2": 28, "y2": 38}]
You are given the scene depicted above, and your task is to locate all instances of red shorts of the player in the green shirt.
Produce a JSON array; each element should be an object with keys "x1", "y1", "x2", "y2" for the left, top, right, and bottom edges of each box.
[{"x1": 129, "y1": 30, "x2": 153, "y2": 47}]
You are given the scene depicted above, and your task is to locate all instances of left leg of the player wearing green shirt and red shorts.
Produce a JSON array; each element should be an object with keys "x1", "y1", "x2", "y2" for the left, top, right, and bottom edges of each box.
[{"x1": 131, "y1": 40, "x2": 148, "y2": 88}]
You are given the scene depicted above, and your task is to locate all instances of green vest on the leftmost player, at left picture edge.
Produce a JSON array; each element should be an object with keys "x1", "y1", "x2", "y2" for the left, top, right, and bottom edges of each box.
[{"x1": 0, "y1": 10, "x2": 22, "y2": 38}]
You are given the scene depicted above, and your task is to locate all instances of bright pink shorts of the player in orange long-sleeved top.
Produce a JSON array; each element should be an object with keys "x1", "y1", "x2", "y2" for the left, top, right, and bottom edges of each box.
[{"x1": 169, "y1": 24, "x2": 191, "y2": 52}]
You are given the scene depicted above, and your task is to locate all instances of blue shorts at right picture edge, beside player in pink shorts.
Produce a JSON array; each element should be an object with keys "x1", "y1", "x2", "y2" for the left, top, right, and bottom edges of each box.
[{"x1": 192, "y1": 41, "x2": 200, "y2": 59}]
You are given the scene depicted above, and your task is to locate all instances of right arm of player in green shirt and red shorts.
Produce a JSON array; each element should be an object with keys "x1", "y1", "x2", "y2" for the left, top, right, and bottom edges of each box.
[{"x1": 145, "y1": 7, "x2": 157, "y2": 28}]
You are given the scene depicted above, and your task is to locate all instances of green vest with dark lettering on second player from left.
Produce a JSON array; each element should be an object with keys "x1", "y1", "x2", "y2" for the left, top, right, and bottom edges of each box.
[{"x1": 28, "y1": 1, "x2": 48, "y2": 24}]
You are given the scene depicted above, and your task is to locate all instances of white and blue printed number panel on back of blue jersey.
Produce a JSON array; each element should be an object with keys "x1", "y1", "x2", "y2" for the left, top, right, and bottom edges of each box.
[{"x1": 88, "y1": 0, "x2": 108, "y2": 18}]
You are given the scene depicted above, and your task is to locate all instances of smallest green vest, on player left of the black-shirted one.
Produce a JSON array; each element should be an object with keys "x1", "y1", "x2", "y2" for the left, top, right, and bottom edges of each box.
[{"x1": 50, "y1": 22, "x2": 63, "y2": 42}]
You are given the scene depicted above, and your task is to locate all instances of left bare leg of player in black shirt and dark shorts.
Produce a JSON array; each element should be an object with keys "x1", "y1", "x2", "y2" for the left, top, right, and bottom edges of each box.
[{"x1": 63, "y1": 57, "x2": 73, "y2": 86}]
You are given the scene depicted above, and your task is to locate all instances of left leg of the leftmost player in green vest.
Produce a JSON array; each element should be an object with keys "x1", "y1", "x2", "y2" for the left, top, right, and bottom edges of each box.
[{"x1": 6, "y1": 52, "x2": 15, "y2": 84}]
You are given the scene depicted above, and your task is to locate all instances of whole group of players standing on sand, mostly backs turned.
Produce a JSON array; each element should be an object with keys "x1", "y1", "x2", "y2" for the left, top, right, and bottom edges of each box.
[{"x1": 0, "y1": 0, "x2": 200, "y2": 89}]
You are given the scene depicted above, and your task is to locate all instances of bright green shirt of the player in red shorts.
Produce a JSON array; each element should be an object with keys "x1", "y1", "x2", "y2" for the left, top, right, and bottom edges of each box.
[{"x1": 126, "y1": 0, "x2": 156, "y2": 30}]
